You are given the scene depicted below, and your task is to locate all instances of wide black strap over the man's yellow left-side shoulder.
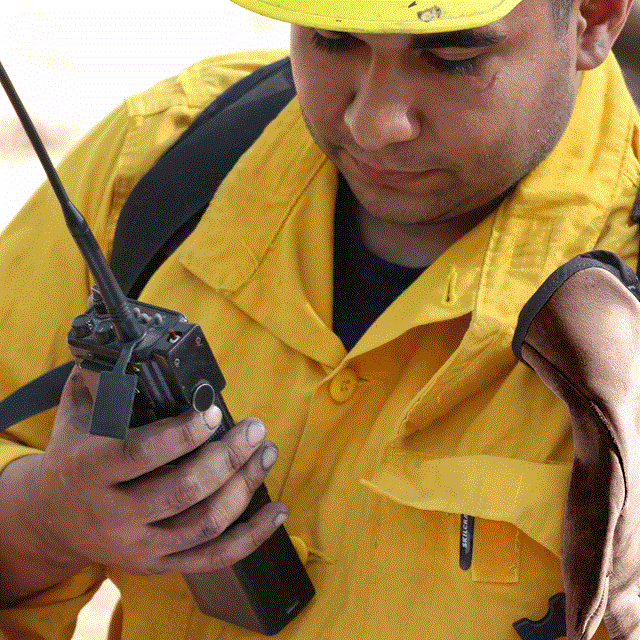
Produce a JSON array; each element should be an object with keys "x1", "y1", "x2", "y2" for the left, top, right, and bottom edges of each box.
[{"x1": 0, "y1": 58, "x2": 295, "y2": 431}]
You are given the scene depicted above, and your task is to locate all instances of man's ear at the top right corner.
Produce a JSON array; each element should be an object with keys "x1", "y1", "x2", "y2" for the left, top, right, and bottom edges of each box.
[{"x1": 577, "y1": 0, "x2": 633, "y2": 71}]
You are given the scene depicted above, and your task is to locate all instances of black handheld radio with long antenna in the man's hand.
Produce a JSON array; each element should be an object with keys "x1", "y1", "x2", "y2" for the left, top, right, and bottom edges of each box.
[{"x1": 0, "y1": 63, "x2": 315, "y2": 635}]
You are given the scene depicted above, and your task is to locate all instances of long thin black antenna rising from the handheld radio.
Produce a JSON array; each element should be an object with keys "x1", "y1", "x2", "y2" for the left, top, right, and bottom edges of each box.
[{"x1": 0, "y1": 57, "x2": 144, "y2": 342}]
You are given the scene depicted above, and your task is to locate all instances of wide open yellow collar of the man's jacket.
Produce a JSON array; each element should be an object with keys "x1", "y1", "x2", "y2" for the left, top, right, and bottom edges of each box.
[{"x1": 178, "y1": 59, "x2": 638, "y2": 370}]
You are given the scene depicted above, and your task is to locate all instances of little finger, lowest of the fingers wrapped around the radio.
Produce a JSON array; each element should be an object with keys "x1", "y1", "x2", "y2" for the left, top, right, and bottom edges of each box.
[{"x1": 156, "y1": 502, "x2": 289, "y2": 574}]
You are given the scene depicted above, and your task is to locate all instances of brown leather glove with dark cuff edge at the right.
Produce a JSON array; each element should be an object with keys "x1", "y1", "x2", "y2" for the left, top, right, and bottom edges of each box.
[{"x1": 513, "y1": 251, "x2": 640, "y2": 640}]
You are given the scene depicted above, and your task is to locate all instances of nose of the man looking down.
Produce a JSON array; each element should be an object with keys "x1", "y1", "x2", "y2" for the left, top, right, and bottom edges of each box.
[{"x1": 343, "y1": 58, "x2": 420, "y2": 151}]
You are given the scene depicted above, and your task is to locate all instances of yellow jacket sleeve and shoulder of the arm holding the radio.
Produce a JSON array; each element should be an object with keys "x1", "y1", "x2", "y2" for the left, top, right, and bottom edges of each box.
[{"x1": 0, "y1": 51, "x2": 286, "y2": 640}]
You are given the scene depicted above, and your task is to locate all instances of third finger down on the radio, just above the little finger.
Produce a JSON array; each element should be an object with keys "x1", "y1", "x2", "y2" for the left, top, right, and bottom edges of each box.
[{"x1": 144, "y1": 442, "x2": 278, "y2": 554}]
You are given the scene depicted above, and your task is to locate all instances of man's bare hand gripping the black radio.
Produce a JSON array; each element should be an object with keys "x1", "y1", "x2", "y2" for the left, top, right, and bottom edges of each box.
[{"x1": 20, "y1": 369, "x2": 288, "y2": 588}]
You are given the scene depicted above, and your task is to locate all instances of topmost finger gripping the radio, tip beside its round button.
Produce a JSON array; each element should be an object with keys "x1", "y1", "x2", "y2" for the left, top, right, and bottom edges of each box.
[{"x1": 95, "y1": 406, "x2": 222, "y2": 484}]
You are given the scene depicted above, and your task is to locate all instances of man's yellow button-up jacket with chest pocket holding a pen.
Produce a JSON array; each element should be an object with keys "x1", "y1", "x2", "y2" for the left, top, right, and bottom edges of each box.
[{"x1": 0, "y1": 47, "x2": 640, "y2": 640}]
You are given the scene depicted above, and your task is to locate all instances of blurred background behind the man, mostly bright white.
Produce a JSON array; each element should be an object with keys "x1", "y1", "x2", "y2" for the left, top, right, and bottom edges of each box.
[{"x1": 0, "y1": 0, "x2": 640, "y2": 640}]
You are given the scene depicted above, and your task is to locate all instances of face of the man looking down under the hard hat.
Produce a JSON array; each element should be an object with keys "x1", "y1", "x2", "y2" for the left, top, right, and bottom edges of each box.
[{"x1": 291, "y1": 0, "x2": 579, "y2": 224}]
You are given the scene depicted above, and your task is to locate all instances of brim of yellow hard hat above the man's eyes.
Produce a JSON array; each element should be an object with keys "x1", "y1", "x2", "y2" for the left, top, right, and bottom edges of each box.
[{"x1": 233, "y1": 0, "x2": 521, "y2": 33}]
